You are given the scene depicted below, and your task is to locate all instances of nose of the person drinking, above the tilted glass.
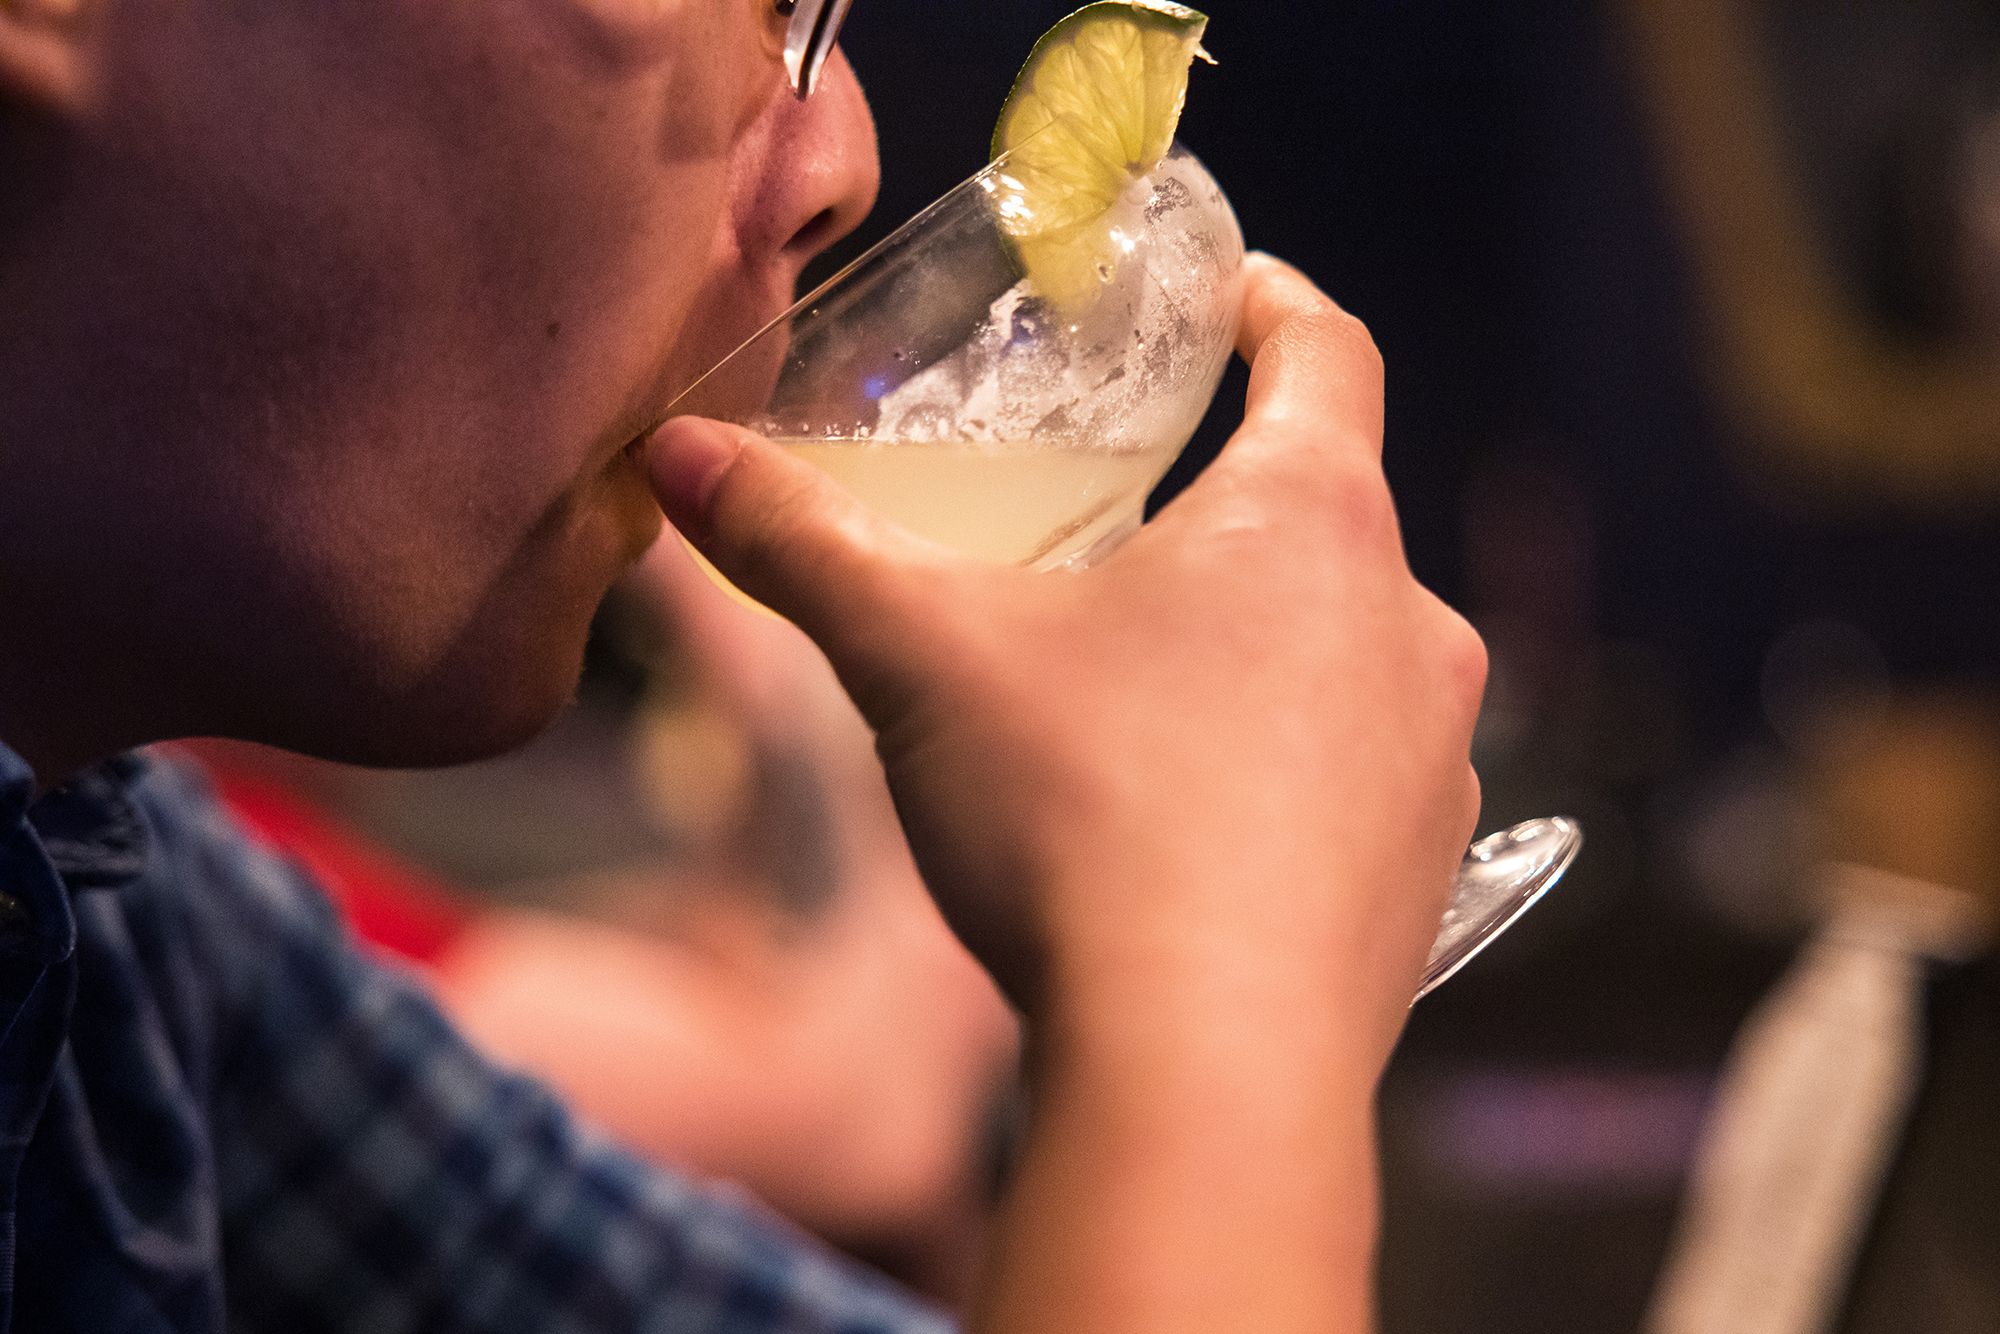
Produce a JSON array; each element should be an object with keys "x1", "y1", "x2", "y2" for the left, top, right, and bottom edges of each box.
[{"x1": 736, "y1": 50, "x2": 882, "y2": 268}]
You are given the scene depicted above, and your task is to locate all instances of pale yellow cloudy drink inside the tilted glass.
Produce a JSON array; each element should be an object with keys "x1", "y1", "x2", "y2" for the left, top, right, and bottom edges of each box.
[{"x1": 774, "y1": 436, "x2": 1178, "y2": 566}]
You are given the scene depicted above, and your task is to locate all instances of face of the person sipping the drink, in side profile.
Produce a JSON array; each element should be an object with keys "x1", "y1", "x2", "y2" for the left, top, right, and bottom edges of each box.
[{"x1": 3, "y1": 0, "x2": 876, "y2": 762}]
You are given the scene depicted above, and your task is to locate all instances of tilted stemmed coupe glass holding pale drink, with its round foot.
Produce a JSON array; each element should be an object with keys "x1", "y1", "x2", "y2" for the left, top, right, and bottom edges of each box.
[{"x1": 670, "y1": 144, "x2": 1580, "y2": 996}]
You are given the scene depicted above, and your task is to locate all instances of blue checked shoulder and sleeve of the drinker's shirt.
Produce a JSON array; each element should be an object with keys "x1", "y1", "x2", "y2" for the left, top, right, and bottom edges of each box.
[{"x1": 109, "y1": 756, "x2": 950, "y2": 1334}]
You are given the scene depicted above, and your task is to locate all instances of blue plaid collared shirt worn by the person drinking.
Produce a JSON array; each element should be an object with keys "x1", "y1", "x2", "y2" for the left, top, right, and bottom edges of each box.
[{"x1": 0, "y1": 746, "x2": 948, "y2": 1334}]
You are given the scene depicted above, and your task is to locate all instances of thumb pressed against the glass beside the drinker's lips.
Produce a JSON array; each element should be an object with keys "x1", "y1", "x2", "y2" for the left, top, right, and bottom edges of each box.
[{"x1": 646, "y1": 416, "x2": 944, "y2": 680}]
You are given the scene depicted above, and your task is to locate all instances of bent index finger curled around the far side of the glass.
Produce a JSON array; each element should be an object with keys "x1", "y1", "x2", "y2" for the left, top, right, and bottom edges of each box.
[{"x1": 1236, "y1": 254, "x2": 1382, "y2": 458}]
